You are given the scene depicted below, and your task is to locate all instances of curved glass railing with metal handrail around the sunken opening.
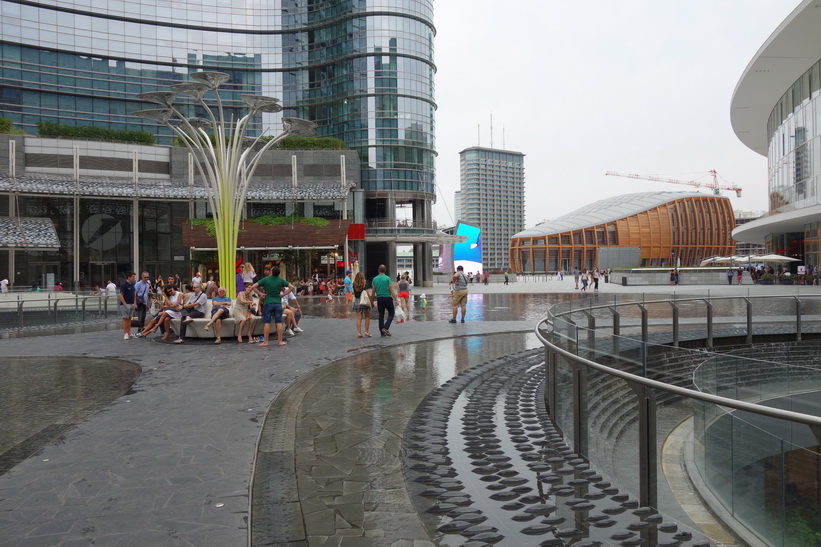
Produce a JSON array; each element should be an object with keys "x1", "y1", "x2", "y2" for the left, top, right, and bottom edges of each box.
[{"x1": 537, "y1": 295, "x2": 821, "y2": 545}]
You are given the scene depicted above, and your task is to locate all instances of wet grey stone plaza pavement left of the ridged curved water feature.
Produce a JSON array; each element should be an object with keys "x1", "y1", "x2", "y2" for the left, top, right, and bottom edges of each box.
[{"x1": 0, "y1": 280, "x2": 812, "y2": 545}]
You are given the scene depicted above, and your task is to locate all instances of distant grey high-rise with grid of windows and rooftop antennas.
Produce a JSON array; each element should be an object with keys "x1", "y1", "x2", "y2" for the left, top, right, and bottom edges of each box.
[{"x1": 459, "y1": 147, "x2": 525, "y2": 270}]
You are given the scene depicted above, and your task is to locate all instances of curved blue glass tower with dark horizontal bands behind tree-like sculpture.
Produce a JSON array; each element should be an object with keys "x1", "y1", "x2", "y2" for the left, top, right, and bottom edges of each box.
[{"x1": 0, "y1": 0, "x2": 436, "y2": 280}]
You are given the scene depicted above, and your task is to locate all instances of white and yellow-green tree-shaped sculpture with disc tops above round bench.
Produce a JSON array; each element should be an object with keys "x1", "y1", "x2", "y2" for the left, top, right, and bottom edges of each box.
[{"x1": 134, "y1": 72, "x2": 316, "y2": 296}]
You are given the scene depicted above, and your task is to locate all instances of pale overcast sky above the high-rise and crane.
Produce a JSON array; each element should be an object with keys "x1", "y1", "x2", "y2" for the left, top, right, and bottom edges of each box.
[{"x1": 433, "y1": 0, "x2": 799, "y2": 228}]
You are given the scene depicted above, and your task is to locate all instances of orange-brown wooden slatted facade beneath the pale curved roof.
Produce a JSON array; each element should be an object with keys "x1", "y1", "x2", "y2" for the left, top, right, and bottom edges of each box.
[{"x1": 510, "y1": 195, "x2": 735, "y2": 273}]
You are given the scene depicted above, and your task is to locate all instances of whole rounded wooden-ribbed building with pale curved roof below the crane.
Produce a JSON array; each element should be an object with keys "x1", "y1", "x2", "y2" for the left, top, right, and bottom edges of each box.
[{"x1": 510, "y1": 192, "x2": 735, "y2": 273}]
